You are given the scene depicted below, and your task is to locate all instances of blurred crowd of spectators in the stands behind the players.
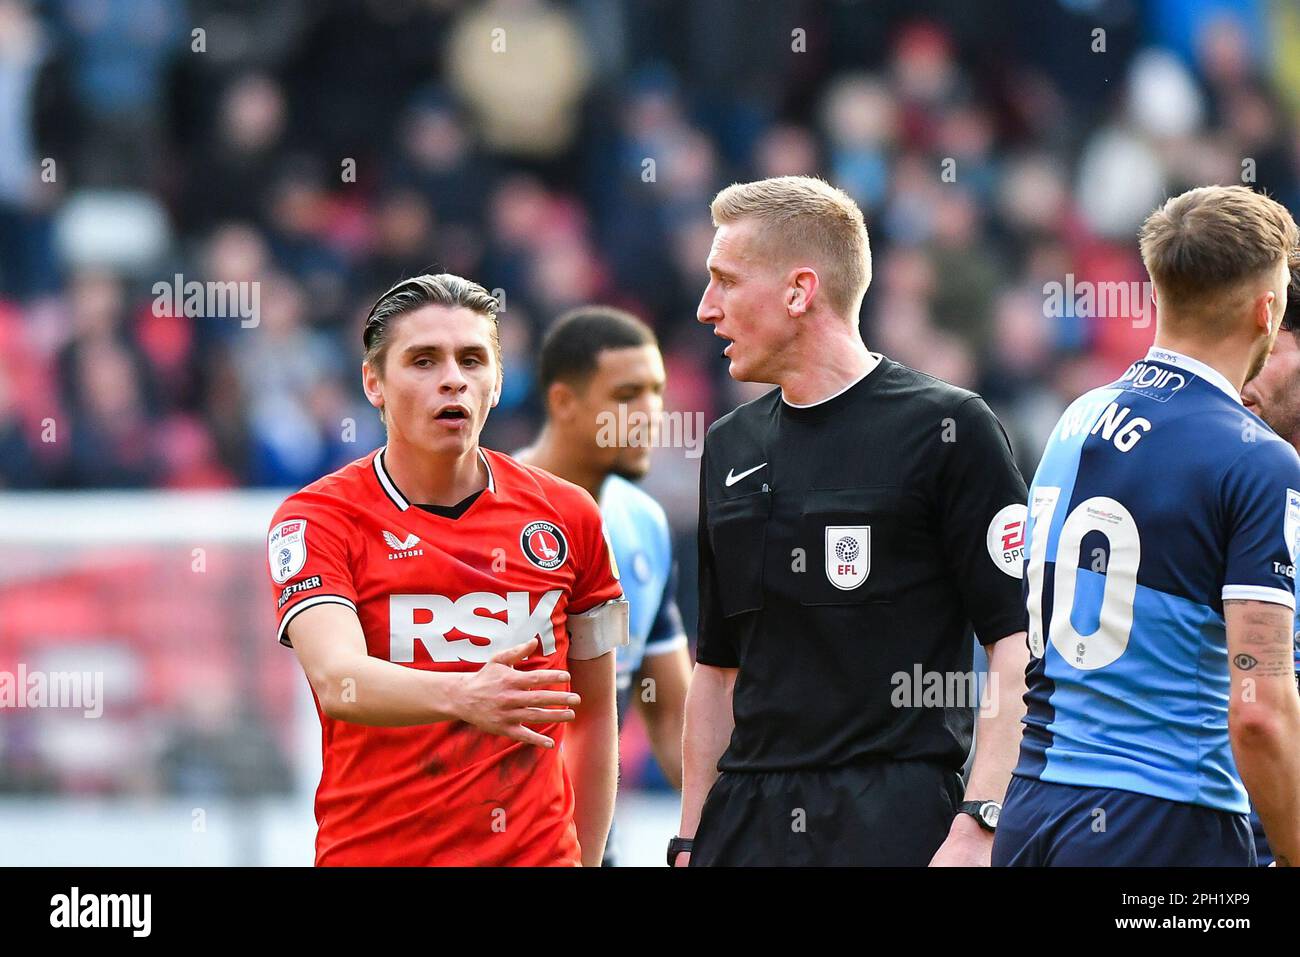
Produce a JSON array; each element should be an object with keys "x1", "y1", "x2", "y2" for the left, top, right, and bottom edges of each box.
[{"x1": 0, "y1": 0, "x2": 1300, "y2": 501}]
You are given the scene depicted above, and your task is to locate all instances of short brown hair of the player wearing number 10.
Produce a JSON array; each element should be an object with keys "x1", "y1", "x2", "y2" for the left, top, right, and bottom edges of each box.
[{"x1": 1138, "y1": 186, "x2": 1300, "y2": 335}]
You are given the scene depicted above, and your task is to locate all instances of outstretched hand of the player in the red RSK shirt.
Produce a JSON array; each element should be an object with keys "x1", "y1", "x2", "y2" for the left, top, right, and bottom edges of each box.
[{"x1": 459, "y1": 638, "x2": 582, "y2": 748}]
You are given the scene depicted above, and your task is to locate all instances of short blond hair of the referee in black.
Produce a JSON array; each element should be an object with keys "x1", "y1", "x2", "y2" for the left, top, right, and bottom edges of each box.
[{"x1": 709, "y1": 176, "x2": 871, "y2": 320}]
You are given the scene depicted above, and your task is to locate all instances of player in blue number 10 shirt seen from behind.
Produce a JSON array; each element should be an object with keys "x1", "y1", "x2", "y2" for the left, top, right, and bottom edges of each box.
[{"x1": 993, "y1": 186, "x2": 1300, "y2": 866}]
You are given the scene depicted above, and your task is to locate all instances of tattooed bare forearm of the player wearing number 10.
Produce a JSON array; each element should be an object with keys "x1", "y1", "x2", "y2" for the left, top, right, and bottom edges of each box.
[{"x1": 1223, "y1": 601, "x2": 1300, "y2": 867}]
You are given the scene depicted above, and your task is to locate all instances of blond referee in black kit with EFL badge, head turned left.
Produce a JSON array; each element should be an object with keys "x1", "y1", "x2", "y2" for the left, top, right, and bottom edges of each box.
[{"x1": 668, "y1": 177, "x2": 1028, "y2": 866}]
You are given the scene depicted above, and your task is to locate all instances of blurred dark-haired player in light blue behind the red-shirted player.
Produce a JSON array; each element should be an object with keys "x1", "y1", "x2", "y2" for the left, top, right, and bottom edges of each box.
[{"x1": 515, "y1": 306, "x2": 692, "y2": 865}]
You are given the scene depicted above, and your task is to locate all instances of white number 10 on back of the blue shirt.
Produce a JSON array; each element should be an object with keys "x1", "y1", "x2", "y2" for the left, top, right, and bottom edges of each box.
[{"x1": 1026, "y1": 486, "x2": 1141, "y2": 671}]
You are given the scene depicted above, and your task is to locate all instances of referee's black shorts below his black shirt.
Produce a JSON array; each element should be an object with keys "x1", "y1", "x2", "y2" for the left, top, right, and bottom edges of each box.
[{"x1": 690, "y1": 759, "x2": 962, "y2": 867}]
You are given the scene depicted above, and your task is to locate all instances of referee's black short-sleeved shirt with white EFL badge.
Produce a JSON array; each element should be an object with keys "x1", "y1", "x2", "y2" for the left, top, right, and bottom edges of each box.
[{"x1": 697, "y1": 358, "x2": 1027, "y2": 771}]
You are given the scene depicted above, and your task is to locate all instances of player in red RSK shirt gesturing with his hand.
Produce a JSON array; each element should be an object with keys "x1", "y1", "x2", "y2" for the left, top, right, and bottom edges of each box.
[{"x1": 269, "y1": 274, "x2": 628, "y2": 866}]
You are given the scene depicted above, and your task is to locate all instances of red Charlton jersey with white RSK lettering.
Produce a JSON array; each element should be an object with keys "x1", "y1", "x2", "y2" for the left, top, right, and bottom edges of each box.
[{"x1": 268, "y1": 450, "x2": 621, "y2": 866}]
